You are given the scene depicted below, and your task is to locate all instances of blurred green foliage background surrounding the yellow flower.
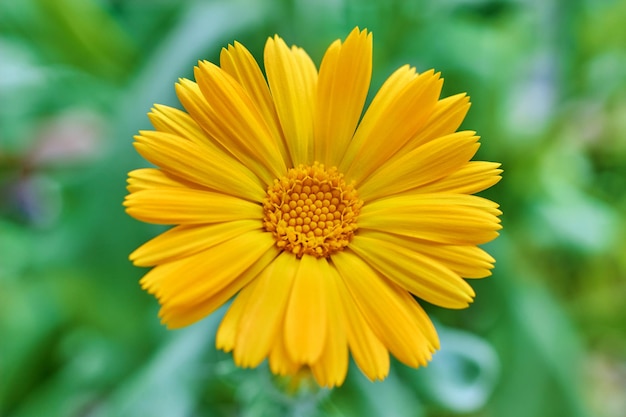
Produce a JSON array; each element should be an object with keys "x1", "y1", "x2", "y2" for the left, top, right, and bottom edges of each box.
[{"x1": 0, "y1": 0, "x2": 626, "y2": 417}]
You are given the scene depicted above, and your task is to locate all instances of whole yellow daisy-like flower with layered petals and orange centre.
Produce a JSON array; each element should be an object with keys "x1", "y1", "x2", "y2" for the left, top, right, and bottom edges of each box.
[{"x1": 124, "y1": 28, "x2": 501, "y2": 386}]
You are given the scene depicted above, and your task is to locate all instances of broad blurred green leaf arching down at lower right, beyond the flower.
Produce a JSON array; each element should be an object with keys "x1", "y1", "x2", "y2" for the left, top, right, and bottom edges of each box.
[{"x1": 490, "y1": 236, "x2": 588, "y2": 417}]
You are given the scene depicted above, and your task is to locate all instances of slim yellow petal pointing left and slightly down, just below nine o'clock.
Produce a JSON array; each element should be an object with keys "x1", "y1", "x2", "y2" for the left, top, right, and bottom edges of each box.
[{"x1": 130, "y1": 220, "x2": 261, "y2": 266}]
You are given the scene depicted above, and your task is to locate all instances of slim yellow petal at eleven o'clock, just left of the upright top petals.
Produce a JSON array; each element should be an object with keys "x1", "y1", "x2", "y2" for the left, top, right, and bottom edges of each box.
[{"x1": 220, "y1": 42, "x2": 289, "y2": 161}]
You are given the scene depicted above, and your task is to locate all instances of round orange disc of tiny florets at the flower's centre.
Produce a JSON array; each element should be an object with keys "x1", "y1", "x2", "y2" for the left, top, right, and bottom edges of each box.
[{"x1": 263, "y1": 162, "x2": 363, "y2": 258}]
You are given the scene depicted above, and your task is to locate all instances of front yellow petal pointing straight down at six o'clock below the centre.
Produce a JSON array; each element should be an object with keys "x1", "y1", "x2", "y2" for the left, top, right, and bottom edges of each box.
[{"x1": 285, "y1": 255, "x2": 328, "y2": 365}]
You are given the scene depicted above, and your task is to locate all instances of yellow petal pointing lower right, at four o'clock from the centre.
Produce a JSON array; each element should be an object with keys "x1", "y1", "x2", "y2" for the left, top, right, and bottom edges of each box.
[{"x1": 350, "y1": 232, "x2": 475, "y2": 308}]
